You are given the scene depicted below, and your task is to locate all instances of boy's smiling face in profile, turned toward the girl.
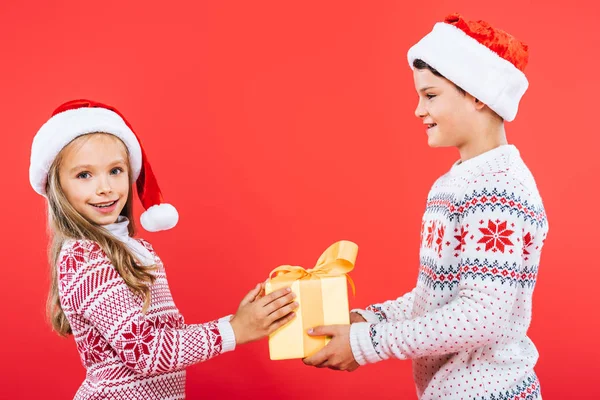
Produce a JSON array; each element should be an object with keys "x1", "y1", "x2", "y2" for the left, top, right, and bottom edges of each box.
[{"x1": 413, "y1": 68, "x2": 477, "y2": 148}]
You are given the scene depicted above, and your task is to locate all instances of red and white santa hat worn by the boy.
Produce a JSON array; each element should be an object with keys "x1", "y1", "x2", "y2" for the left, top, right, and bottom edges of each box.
[{"x1": 408, "y1": 14, "x2": 529, "y2": 121}]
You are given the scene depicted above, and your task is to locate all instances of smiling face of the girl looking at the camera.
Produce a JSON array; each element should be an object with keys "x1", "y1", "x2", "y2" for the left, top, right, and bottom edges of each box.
[{"x1": 58, "y1": 134, "x2": 130, "y2": 225}]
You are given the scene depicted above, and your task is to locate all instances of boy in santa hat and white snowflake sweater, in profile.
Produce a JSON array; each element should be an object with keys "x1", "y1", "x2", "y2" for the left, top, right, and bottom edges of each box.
[{"x1": 305, "y1": 14, "x2": 548, "y2": 400}]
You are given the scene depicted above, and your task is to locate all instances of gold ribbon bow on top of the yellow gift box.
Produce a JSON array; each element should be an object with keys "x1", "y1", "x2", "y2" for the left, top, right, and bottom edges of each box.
[{"x1": 269, "y1": 240, "x2": 358, "y2": 295}]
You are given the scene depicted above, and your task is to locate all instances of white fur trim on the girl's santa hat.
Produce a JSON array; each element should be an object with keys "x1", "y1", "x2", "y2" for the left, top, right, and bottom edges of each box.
[{"x1": 29, "y1": 107, "x2": 142, "y2": 195}]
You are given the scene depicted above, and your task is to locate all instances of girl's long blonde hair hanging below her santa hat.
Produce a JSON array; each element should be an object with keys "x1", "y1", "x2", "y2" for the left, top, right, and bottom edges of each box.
[{"x1": 46, "y1": 132, "x2": 155, "y2": 336}]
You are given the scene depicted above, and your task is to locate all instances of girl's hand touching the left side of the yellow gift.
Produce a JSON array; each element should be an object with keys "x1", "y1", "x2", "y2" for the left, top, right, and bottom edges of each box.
[{"x1": 230, "y1": 283, "x2": 298, "y2": 344}]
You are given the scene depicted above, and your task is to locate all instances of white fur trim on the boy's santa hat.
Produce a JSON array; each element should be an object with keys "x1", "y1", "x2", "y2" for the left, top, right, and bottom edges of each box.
[{"x1": 408, "y1": 22, "x2": 529, "y2": 121}]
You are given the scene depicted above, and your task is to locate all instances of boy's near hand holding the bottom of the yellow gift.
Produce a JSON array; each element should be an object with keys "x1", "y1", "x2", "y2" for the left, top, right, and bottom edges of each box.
[{"x1": 302, "y1": 325, "x2": 359, "y2": 372}]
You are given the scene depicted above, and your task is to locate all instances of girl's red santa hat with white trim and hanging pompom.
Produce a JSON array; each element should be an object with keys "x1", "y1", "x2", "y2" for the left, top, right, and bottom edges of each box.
[{"x1": 29, "y1": 100, "x2": 179, "y2": 232}]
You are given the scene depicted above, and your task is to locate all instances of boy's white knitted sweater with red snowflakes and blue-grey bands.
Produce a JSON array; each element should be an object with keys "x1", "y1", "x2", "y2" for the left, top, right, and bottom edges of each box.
[{"x1": 350, "y1": 145, "x2": 548, "y2": 400}]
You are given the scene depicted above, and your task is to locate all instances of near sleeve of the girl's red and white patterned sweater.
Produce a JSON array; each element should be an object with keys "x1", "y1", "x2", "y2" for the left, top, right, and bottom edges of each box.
[{"x1": 57, "y1": 241, "x2": 235, "y2": 374}]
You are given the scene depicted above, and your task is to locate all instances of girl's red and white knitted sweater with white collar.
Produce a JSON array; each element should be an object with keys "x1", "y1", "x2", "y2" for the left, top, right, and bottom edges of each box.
[{"x1": 57, "y1": 217, "x2": 235, "y2": 400}]
